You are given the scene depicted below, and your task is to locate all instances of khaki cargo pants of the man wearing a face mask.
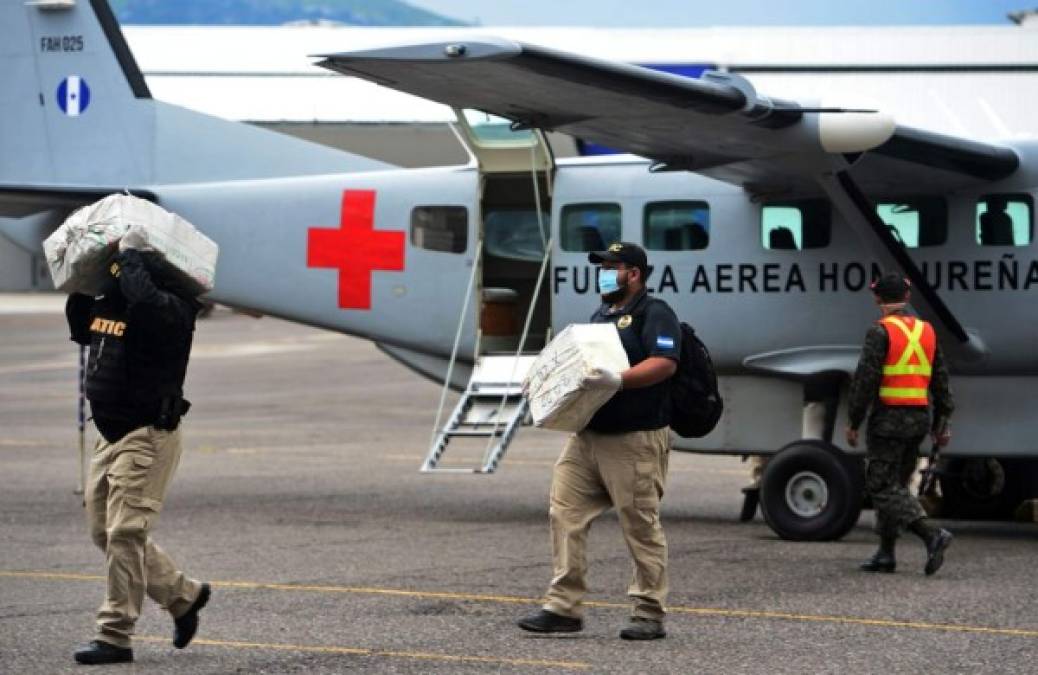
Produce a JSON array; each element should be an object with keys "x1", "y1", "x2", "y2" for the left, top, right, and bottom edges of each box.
[{"x1": 544, "y1": 428, "x2": 671, "y2": 619}]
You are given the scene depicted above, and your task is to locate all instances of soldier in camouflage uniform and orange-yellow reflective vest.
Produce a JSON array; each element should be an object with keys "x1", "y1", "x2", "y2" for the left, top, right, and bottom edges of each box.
[{"x1": 847, "y1": 274, "x2": 954, "y2": 574}]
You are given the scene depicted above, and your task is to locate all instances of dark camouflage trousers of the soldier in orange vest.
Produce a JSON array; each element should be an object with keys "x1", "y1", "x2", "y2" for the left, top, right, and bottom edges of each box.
[{"x1": 865, "y1": 434, "x2": 926, "y2": 539}]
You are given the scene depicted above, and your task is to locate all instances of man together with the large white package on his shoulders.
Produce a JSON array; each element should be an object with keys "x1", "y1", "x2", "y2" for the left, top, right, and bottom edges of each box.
[{"x1": 45, "y1": 195, "x2": 216, "y2": 665}]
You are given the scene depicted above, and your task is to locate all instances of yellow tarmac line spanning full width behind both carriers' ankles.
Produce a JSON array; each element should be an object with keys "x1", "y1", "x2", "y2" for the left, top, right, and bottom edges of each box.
[{"x1": 0, "y1": 571, "x2": 1038, "y2": 638}]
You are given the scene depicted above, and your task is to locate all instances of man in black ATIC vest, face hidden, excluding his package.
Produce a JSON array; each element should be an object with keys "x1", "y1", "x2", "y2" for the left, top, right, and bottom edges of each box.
[{"x1": 65, "y1": 249, "x2": 210, "y2": 664}]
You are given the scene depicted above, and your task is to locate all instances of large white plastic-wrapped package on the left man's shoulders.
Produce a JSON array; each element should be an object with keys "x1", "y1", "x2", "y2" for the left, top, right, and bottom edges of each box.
[{"x1": 44, "y1": 194, "x2": 219, "y2": 295}]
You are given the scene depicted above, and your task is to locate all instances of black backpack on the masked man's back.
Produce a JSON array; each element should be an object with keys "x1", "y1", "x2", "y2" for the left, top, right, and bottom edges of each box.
[{"x1": 671, "y1": 323, "x2": 725, "y2": 438}]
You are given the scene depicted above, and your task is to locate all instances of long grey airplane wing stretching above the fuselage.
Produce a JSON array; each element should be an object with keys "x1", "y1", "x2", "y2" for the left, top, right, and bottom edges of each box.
[{"x1": 319, "y1": 37, "x2": 1019, "y2": 196}]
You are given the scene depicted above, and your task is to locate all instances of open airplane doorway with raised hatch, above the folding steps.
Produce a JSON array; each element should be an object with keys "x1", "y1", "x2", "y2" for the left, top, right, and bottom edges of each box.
[{"x1": 455, "y1": 109, "x2": 554, "y2": 353}]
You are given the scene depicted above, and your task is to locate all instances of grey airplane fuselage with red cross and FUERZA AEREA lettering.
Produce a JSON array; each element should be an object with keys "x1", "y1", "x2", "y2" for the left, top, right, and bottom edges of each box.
[{"x1": 156, "y1": 144, "x2": 1038, "y2": 454}]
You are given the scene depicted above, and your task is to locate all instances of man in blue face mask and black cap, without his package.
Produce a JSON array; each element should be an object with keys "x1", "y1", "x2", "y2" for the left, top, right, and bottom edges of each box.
[{"x1": 519, "y1": 242, "x2": 681, "y2": 640}]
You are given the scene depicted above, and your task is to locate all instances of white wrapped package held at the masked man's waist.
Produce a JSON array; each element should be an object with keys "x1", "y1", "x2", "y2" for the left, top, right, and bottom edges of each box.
[{"x1": 526, "y1": 323, "x2": 629, "y2": 432}]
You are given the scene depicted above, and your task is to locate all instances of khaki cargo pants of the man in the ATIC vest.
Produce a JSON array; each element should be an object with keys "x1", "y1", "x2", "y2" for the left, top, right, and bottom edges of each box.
[{"x1": 86, "y1": 427, "x2": 201, "y2": 647}]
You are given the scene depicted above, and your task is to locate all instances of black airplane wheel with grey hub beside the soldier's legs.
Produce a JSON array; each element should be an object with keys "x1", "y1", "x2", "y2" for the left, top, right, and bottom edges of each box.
[{"x1": 761, "y1": 440, "x2": 865, "y2": 541}]
